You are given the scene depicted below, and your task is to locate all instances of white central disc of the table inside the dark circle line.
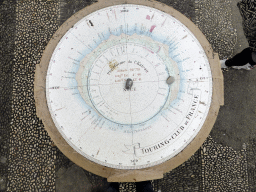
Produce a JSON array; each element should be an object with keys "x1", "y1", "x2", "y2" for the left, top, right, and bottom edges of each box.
[{"x1": 88, "y1": 45, "x2": 169, "y2": 124}]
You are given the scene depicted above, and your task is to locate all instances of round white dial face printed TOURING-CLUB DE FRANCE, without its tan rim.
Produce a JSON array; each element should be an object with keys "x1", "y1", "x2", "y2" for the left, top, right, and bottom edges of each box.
[{"x1": 46, "y1": 5, "x2": 212, "y2": 169}]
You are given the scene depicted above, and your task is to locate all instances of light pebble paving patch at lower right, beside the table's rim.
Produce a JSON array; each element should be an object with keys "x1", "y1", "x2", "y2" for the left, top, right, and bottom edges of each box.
[{"x1": 201, "y1": 136, "x2": 248, "y2": 191}]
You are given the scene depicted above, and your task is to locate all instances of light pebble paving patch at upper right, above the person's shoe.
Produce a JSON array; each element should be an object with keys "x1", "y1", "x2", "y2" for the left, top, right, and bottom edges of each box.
[{"x1": 194, "y1": 0, "x2": 237, "y2": 59}]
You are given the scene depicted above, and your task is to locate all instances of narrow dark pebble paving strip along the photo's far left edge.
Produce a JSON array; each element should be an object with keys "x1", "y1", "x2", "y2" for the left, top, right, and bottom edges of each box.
[{"x1": 0, "y1": 0, "x2": 16, "y2": 191}]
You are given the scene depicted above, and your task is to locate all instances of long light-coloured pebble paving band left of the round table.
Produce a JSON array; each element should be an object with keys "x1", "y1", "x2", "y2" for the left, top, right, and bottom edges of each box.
[{"x1": 7, "y1": 0, "x2": 58, "y2": 191}]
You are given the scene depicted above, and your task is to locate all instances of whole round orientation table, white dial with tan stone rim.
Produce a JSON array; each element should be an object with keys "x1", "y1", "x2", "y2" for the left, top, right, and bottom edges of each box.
[{"x1": 35, "y1": 0, "x2": 224, "y2": 182}]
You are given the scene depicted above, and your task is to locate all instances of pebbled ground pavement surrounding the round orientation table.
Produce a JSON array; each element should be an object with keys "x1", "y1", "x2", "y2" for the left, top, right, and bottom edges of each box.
[{"x1": 0, "y1": 0, "x2": 256, "y2": 192}]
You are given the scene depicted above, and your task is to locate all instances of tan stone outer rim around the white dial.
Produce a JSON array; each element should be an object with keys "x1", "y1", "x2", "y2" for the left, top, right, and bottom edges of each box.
[{"x1": 34, "y1": 0, "x2": 224, "y2": 182}]
